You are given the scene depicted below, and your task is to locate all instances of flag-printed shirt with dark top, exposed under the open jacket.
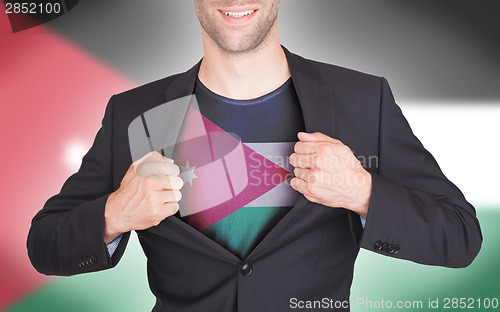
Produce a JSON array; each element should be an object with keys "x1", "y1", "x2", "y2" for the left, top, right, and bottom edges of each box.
[{"x1": 173, "y1": 78, "x2": 305, "y2": 259}]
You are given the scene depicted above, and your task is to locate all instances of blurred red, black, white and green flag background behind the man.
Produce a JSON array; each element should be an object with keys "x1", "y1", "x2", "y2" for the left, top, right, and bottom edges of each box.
[{"x1": 0, "y1": 0, "x2": 500, "y2": 312}]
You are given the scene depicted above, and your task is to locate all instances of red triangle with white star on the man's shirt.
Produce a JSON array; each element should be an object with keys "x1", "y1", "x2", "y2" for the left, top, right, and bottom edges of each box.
[{"x1": 172, "y1": 107, "x2": 292, "y2": 231}]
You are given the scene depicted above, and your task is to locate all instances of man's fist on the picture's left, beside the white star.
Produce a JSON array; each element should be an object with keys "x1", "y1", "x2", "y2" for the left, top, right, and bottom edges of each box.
[{"x1": 104, "y1": 152, "x2": 183, "y2": 244}]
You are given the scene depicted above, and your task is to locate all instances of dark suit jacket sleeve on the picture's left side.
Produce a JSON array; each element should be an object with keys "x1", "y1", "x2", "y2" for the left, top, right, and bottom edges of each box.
[{"x1": 27, "y1": 97, "x2": 130, "y2": 276}]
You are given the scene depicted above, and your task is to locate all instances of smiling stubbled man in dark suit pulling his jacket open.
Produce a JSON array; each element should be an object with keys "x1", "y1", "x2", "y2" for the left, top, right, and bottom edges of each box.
[{"x1": 27, "y1": 0, "x2": 482, "y2": 311}]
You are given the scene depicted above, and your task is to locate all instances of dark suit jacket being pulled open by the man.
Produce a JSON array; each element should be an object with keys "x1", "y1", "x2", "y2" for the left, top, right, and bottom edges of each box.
[{"x1": 27, "y1": 48, "x2": 482, "y2": 312}]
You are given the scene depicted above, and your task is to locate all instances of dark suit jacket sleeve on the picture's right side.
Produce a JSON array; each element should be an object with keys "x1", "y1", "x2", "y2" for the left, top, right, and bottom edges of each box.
[{"x1": 360, "y1": 78, "x2": 482, "y2": 267}]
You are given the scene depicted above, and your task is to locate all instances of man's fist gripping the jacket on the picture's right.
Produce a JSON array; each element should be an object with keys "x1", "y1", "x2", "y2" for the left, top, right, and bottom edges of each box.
[{"x1": 290, "y1": 132, "x2": 372, "y2": 218}]
